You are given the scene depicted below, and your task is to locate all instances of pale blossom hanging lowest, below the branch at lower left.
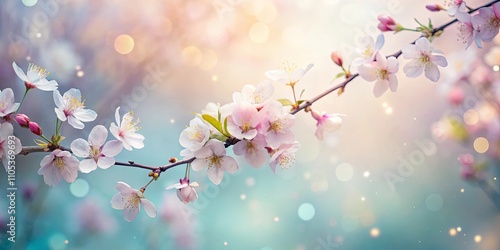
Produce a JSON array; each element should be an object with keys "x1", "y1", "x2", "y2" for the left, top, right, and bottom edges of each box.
[{"x1": 110, "y1": 181, "x2": 156, "y2": 222}]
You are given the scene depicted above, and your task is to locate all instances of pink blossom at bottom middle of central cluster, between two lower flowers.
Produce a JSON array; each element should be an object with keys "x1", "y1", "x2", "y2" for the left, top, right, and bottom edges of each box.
[{"x1": 233, "y1": 134, "x2": 267, "y2": 168}]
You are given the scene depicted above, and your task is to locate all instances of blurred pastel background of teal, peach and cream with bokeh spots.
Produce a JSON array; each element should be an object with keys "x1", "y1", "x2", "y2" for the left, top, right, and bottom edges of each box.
[{"x1": 0, "y1": 0, "x2": 500, "y2": 250}]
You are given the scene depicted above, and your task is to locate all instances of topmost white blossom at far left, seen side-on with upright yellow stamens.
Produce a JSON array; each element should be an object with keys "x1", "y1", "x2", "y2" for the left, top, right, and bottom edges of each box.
[{"x1": 12, "y1": 62, "x2": 57, "y2": 91}]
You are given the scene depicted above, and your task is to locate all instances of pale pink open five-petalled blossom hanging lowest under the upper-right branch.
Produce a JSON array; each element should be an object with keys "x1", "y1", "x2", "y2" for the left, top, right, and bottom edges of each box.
[{"x1": 402, "y1": 37, "x2": 448, "y2": 82}]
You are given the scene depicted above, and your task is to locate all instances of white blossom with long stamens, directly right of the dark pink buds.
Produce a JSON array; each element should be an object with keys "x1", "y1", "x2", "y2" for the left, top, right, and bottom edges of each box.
[{"x1": 54, "y1": 88, "x2": 97, "y2": 129}]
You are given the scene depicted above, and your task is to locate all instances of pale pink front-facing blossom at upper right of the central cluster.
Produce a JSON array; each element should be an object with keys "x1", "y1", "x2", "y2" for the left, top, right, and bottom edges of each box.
[{"x1": 259, "y1": 101, "x2": 295, "y2": 148}]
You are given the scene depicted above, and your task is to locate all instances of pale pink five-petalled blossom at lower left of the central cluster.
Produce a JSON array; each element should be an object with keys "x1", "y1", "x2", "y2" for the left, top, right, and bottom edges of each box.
[{"x1": 191, "y1": 139, "x2": 238, "y2": 185}]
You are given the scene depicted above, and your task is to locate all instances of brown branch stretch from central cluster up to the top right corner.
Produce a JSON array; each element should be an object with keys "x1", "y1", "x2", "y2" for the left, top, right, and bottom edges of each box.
[{"x1": 290, "y1": 0, "x2": 500, "y2": 115}]
